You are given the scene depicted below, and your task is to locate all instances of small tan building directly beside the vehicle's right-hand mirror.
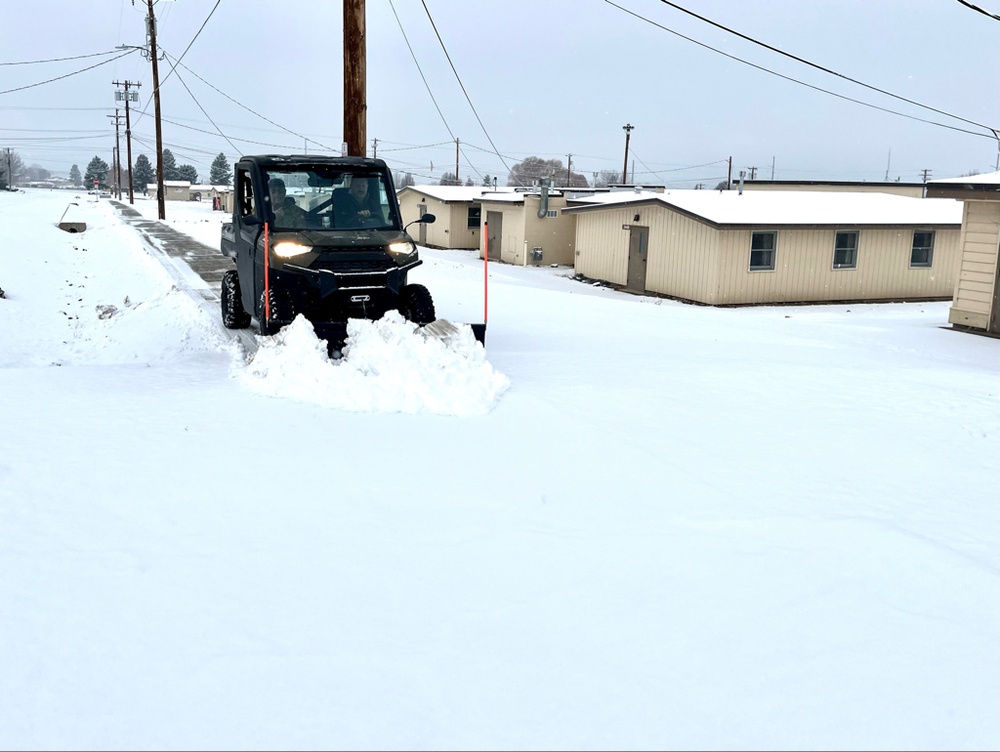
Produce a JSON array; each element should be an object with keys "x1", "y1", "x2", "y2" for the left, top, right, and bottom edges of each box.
[{"x1": 398, "y1": 185, "x2": 513, "y2": 250}]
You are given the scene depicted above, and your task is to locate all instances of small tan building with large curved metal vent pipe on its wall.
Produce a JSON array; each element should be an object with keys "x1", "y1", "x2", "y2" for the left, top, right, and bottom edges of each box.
[{"x1": 478, "y1": 190, "x2": 576, "y2": 266}]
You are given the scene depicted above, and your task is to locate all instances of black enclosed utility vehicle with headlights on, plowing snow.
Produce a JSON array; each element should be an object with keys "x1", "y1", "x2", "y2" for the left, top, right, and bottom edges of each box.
[{"x1": 222, "y1": 155, "x2": 435, "y2": 349}]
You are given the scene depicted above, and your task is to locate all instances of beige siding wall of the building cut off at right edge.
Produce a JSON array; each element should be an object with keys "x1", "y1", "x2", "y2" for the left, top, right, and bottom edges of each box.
[{"x1": 948, "y1": 200, "x2": 1000, "y2": 329}]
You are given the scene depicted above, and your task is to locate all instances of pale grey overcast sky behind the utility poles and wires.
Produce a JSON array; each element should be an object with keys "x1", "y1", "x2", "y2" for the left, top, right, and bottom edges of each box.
[{"x1": 0, "y1": 0, "x2": 1000, "y2": 188}]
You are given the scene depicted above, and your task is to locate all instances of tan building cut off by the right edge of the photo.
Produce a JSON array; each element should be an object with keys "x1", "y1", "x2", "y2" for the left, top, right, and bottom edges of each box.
[{"x1": 927, "y1": 172, "x2": 1000, "y2": 335}]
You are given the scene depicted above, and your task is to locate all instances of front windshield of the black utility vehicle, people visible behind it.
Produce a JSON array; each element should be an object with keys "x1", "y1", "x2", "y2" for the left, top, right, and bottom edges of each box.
[{"x1": 264, "y1": 167, "x2": 399, "y2": 230}]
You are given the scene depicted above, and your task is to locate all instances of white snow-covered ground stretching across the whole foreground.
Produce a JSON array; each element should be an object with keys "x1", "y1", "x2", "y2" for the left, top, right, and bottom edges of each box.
[{"x1": 0, "y1": 191, "x2": 1000, "y2": 749}]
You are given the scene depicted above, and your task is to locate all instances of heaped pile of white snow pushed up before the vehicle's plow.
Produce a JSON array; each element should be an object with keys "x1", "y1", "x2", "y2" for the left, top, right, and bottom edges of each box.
[{"x1": 239, "y1": 311, "x2": 510, "y2": 416}]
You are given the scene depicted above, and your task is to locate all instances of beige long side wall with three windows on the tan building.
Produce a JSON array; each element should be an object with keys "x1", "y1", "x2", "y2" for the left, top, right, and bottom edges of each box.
[{"x1": 705, "y1": 227, "x2": 960, "y2": 305}]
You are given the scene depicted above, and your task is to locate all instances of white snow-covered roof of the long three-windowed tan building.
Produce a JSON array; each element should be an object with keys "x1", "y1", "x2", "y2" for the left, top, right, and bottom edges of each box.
[{"x1": 562, "y1": 190, "x2": 962, "y2": 226}]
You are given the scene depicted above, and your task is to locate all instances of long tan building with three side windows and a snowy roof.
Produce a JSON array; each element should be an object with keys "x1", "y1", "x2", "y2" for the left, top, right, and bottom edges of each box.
[{"x1": 562, "y1": 190, "x2": 962, "y2": 305}]
